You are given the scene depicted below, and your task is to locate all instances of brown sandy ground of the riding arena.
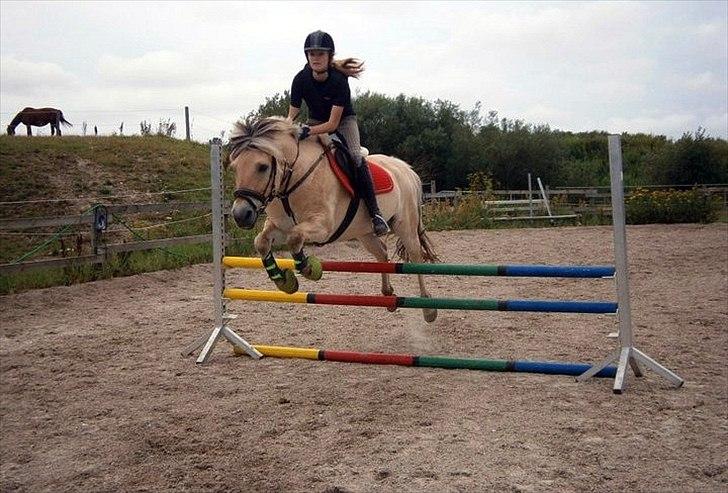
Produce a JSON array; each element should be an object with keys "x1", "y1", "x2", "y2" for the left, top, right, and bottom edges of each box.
[{"x1": 0, "y1": 224, "x2": 728, "y2": 492}]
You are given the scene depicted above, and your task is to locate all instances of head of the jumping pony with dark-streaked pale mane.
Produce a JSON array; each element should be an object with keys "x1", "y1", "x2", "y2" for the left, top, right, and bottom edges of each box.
[{"x1": 228, "y1": 117, "x2": 298, "y2": 229}]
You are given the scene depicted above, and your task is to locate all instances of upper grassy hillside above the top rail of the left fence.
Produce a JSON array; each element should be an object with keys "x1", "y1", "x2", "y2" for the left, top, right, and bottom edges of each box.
[{"x1": 0, "y1": 135, "x2": 210, "y2": 218}]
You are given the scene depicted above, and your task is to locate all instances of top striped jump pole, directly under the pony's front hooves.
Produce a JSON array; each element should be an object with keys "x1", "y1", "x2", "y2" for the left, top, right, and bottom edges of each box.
[{"x1": 223, "y1": 257, "x2": 614, "y2": 278}]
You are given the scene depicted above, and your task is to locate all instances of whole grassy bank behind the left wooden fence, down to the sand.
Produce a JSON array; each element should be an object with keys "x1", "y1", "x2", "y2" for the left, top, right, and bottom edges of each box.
[{"x1": 0, "y1": 136, "x2": 253, "y2": 293}]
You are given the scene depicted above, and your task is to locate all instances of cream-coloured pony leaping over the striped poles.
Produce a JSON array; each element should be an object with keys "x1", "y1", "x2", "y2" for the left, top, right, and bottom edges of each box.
[{"x1": 229, "y1": 117, "x2": 437, "y2": 322}]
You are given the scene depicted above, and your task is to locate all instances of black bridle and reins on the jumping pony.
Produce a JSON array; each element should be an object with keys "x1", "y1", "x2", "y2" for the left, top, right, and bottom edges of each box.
[{"x1": 233, "y1": 141, "x2": 325, "y2": 223}]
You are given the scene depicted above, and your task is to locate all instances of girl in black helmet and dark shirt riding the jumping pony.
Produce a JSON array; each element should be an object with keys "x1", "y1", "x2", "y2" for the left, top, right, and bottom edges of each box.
[{"x1": 288, "y1": 31, "x2": 389, "y2": 236}]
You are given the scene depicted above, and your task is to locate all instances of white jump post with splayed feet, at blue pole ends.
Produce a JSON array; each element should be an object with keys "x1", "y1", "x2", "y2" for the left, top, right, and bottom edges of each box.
[{"x1": 576, "y1": 135, "x2": 683, "y2": 394}]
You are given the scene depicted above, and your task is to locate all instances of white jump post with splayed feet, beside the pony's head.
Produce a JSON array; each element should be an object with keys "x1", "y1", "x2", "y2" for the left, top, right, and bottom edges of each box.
[{"x1": 182, "y1": 139, "x2": 263, "y2": 363}]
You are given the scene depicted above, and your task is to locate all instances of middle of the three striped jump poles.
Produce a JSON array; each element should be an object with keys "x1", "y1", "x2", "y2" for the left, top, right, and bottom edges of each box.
[{"x1": 223, "y1": 288, "x2": 617, "y2": 314}]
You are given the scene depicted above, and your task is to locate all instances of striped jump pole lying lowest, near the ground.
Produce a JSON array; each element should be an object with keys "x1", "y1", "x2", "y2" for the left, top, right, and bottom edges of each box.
[{"x1": 235, "y1": 345, "x2": 617, "y2": 378}]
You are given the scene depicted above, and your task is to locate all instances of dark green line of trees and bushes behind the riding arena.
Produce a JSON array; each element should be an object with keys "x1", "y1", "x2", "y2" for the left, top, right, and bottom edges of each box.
[{"x1": 246, "y1": 91, "x2": 728, "y2": 189}]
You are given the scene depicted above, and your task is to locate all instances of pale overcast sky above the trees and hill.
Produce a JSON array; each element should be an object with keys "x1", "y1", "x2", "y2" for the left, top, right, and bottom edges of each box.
[{"x1": 0, "y1": 1, "x2": 728, "y2": 140}]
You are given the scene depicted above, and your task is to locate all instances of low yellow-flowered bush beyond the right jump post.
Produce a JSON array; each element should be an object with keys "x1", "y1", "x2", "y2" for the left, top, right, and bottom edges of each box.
[{"x1": 625, "y1": 188, "x2": 721, "y2": 224}]
